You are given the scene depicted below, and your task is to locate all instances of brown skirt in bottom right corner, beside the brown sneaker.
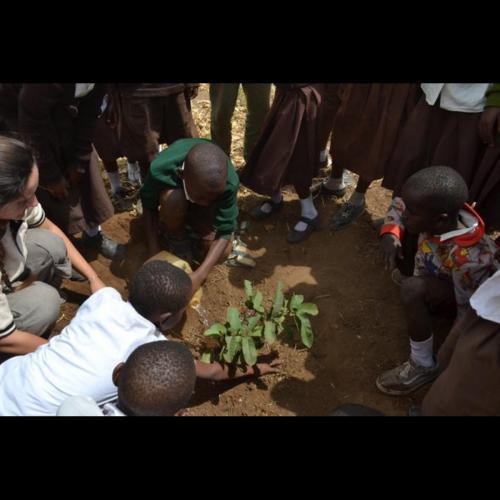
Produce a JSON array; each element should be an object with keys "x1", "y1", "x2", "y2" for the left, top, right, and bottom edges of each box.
[{"x1": 422, "y1": 308, "x2": 500, "y2": 416}]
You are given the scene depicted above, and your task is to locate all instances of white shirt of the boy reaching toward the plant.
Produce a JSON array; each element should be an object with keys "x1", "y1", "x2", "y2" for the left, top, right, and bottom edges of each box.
[{"x1": 0, "y1": 287, "x2": 166, "y2": 415}]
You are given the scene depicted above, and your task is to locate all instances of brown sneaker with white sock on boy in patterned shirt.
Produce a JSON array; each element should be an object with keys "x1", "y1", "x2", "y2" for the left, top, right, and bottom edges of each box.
[{"x1": 376, "y1": 359, "x2": 439, "y2": 396}]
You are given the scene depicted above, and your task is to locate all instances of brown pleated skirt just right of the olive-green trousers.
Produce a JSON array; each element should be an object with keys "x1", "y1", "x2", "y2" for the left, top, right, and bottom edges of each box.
[{"x1": 240, "y1": 85, "x2": 321, "y2": 196}]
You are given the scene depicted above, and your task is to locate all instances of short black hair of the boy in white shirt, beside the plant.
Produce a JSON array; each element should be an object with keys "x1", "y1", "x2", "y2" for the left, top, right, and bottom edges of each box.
[{"x1": 128, "y1": 260, "x2": 192, "y2": 319}]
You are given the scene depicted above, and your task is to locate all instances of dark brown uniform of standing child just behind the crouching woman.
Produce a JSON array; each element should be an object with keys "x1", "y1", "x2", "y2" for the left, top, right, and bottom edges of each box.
[{"x1": 12, "y1": 83, "x2": 114, "y2": 235}]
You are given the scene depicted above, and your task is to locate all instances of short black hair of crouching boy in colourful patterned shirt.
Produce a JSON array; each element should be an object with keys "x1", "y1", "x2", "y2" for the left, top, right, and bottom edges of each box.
[{"x1": 403, "y1": 166, "x2": 469, "y2": 215}]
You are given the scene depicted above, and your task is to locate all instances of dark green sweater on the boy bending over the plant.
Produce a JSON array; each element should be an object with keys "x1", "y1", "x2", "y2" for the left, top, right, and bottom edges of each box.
[{"x1": 140, "y1": 139, "x2": 240, "y2": 240}]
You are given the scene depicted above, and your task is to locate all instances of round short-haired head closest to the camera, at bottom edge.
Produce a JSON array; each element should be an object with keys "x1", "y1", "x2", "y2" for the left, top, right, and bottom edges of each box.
[{"x1": 118, "y1": 341, "x2": 196, "y2": 416}]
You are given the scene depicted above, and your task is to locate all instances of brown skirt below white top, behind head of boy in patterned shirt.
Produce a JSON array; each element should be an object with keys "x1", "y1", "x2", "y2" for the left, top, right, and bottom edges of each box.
[{"x1": 382, "y1": 95, "x2": 484, "y2": 194}]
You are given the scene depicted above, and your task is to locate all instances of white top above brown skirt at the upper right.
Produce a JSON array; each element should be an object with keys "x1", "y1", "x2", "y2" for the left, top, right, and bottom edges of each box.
[{"x1": 420, "y1": 83, "x2": 490, "y2": 113}]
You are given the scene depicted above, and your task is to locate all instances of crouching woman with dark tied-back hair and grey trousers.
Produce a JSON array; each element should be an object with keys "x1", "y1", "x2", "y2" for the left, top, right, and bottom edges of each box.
[{"x1": 0, "y1": 136, "x2": 104, "y2": 354}]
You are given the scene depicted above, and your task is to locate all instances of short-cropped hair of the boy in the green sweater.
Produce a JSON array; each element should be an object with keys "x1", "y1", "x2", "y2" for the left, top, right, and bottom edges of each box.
[{"x1": 186, "y1": 142, "x2": 227, "y2": 192}]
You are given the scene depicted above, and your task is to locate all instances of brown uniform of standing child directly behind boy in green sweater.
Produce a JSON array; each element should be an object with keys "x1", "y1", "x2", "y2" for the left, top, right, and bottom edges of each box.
[{"x1": 110, "y1": 83, "x2": 199, "y2": 164}]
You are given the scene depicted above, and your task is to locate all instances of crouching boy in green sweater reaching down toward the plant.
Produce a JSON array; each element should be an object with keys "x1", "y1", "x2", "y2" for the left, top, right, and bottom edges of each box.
[{"x1": 140, "y1": 139, "x2": 239, "y2": 292}]
